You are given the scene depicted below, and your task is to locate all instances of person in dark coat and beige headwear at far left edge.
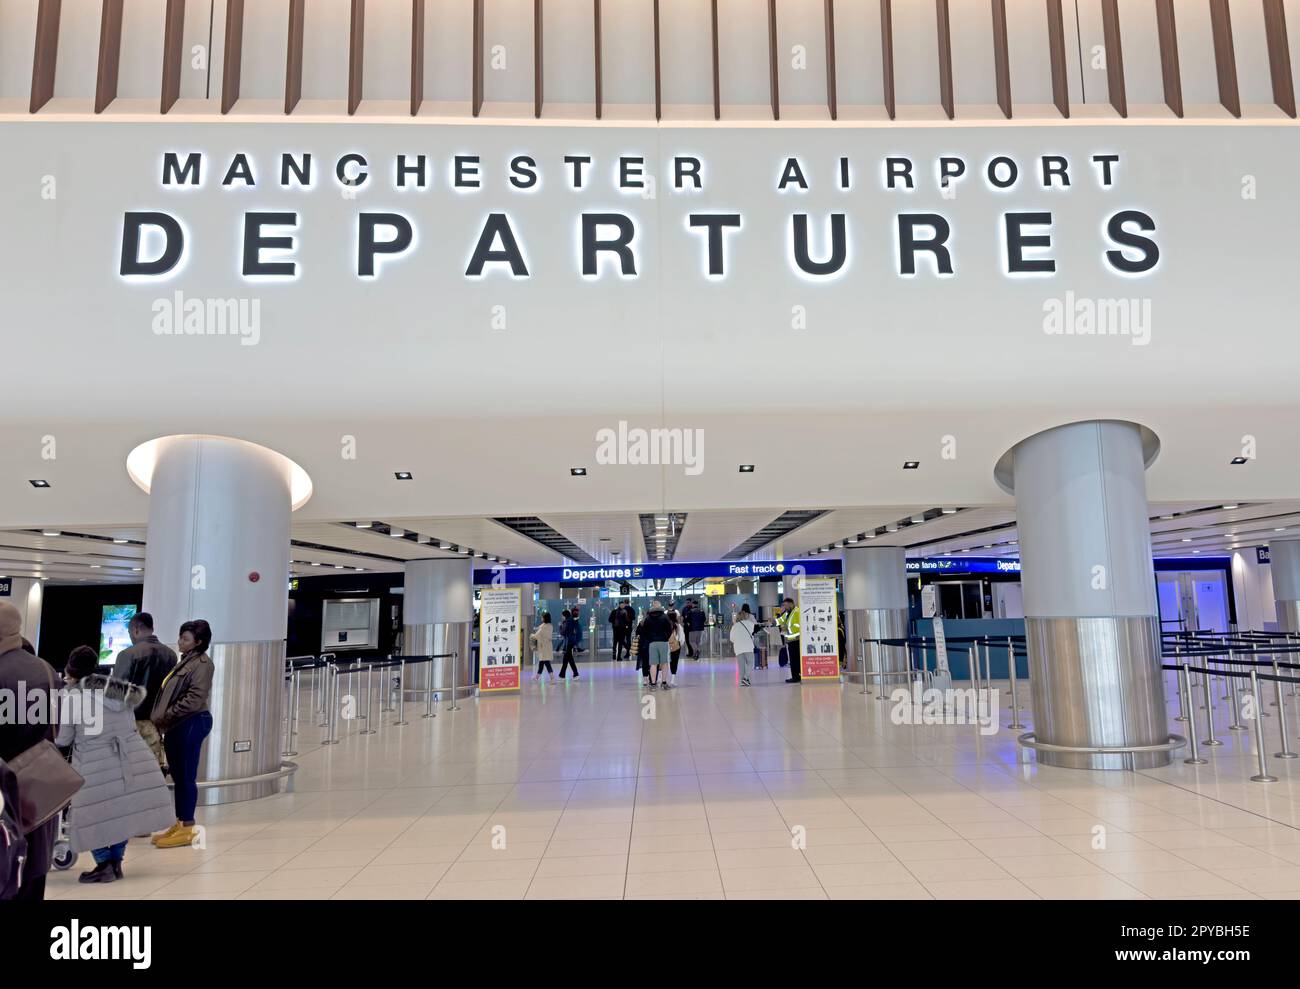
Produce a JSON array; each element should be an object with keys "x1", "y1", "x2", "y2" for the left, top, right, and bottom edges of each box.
[{"x1": 0, "y1": 602, "x2": 59, "y2": 902}]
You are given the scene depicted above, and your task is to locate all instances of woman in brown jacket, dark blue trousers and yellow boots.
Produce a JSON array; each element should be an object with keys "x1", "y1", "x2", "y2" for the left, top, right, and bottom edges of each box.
[{"x1": 151, "y1": 619, "x2": 213, "y2": 849}]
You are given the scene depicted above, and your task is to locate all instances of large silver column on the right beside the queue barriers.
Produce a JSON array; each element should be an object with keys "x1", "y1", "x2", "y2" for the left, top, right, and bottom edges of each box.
[{"x1": 996, "y1": 421, "x2": 1170, "y2": 769}]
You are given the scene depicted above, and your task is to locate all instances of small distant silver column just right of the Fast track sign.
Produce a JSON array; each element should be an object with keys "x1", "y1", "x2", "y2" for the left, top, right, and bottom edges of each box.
[{"x1": 842, "y1": 546, "x2": 907, "y2": 673}]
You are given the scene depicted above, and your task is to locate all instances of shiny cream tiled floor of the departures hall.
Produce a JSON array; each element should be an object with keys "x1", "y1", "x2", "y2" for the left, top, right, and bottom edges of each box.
[{"x1": 49, "y1": 660, "x2": 1300, "y2": 899}]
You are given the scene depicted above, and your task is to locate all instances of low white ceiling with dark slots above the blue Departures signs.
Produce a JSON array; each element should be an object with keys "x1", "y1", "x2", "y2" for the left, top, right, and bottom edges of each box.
[{"x1": 0, "y1": 502, "x2": 1300, "y2": 584}]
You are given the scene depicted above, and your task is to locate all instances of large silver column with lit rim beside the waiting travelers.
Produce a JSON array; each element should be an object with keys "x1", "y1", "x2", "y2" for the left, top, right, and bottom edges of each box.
[{"x1": 127, "y1": 435, "x2": 311, "y2": 804}]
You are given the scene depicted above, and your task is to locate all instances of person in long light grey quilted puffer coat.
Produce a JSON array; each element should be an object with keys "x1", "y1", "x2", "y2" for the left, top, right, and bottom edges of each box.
[{"x1": 55, "y1": 646, "x2": 172, "y2": 882}]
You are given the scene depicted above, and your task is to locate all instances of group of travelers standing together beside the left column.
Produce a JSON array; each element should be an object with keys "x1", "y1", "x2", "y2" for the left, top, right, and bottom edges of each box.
[{"x1": 0, "y1": 602, "x2": 213, "y2": 901}]
